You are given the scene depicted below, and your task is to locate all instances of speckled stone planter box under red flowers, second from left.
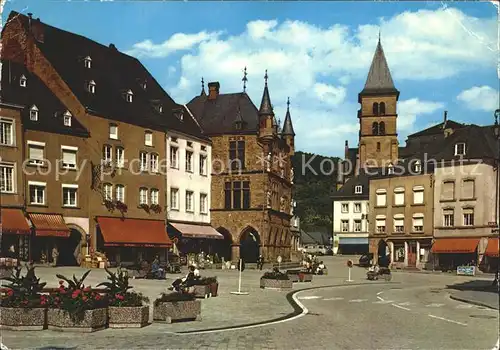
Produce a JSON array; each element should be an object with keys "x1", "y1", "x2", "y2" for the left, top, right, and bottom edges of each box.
[{"x1": 47, "y1": 308, "x2": 108, "y2": 333}]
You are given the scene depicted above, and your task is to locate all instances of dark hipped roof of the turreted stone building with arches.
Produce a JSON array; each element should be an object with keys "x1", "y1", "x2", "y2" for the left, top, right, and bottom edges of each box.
[{"x1": 187, "y1": 92, "x2": 259, "y2": 135}]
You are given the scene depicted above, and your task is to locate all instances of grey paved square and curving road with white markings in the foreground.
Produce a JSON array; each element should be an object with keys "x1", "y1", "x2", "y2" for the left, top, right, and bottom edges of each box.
[{"x1": 2, "y1": 258, "x2": 498, "y2": 350}]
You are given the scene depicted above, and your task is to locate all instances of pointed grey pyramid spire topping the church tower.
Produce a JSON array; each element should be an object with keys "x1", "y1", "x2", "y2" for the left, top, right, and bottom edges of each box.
[{"x1": 361, "y1": 40, "x2": 399, "y2": 94}]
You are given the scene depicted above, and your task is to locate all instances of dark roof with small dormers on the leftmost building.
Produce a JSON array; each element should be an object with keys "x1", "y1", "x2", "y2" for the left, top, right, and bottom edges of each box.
[{"x1": 2, "y1": 61, "x2": 89, "y2": 137}]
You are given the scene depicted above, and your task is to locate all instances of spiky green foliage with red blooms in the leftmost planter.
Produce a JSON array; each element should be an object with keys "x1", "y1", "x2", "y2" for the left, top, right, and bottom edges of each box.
[{"x1": 1, "y1": 266, "x2": 47, "y2": 308}]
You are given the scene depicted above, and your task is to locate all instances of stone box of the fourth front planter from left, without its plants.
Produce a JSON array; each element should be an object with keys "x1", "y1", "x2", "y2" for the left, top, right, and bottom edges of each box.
[{"x1": 153, "y1": 300, "x2": 201, "y2": 323}]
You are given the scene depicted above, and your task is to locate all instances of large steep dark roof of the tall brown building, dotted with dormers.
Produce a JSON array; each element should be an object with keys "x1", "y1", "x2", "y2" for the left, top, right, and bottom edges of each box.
[{"x1": 9, "y1": 11, "x2": 209, "y2": 139}]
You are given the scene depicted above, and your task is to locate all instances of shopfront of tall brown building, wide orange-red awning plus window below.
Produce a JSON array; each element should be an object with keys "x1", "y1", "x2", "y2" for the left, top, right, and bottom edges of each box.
[{"x1": 97, "y1": 217, "x2": 172, "y2": 264}]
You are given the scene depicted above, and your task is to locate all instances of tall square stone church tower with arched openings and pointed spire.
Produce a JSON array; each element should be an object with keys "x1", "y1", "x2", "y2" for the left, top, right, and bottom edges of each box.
[{"x1": 358, "y1": 37, "x2": 399, "y2": 167}]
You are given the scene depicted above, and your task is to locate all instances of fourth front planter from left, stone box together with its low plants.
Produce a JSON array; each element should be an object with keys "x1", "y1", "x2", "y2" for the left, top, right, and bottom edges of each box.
[{"x1": 153, "y1": 293, "x2": 201, "y2": 323}]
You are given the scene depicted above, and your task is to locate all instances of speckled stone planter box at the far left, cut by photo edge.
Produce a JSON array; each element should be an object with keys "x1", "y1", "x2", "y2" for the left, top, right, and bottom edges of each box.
[{"x1": 0, "y1": 307, "x2": 47, "y2": 331}]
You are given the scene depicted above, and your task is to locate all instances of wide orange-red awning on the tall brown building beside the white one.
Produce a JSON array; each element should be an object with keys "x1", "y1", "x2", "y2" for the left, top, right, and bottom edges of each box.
[{"x1": 97, "y1": 217, "x2": 172, "y2": 248}]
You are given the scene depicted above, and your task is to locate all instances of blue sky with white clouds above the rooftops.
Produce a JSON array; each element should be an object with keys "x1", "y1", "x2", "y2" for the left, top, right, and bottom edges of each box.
[{"x1": 3, "y1": 0, "x2": 500, "y2": 156}]
